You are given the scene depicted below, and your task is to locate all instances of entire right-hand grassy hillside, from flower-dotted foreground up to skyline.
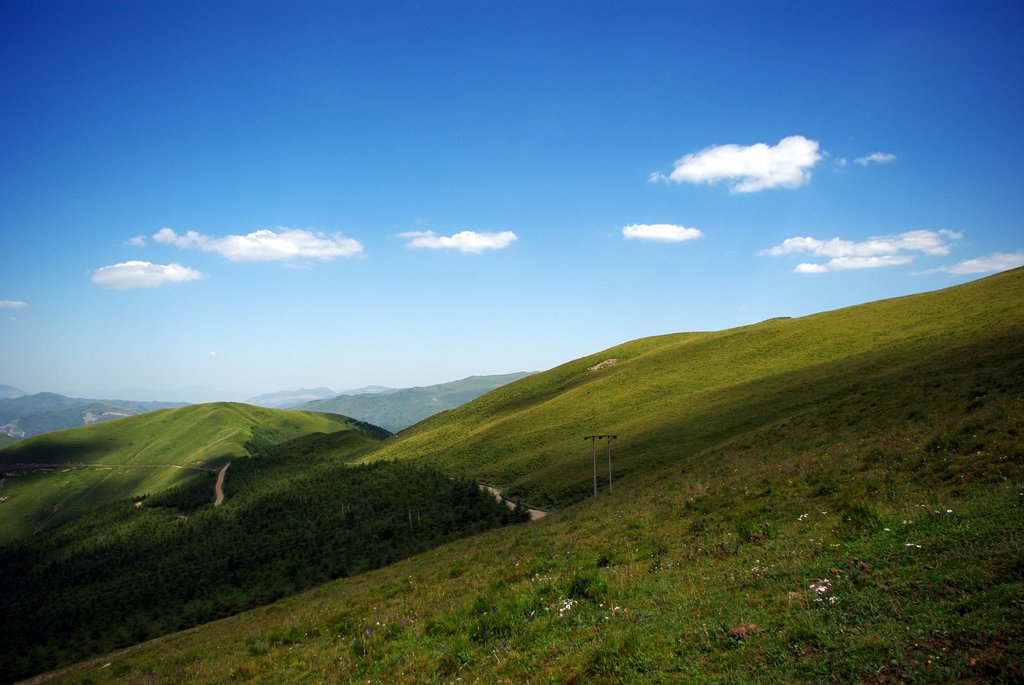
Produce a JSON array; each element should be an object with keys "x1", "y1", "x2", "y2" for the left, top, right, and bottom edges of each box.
[{"x1": 36, "y1": 270, "x2": 1024, "y2": 683}]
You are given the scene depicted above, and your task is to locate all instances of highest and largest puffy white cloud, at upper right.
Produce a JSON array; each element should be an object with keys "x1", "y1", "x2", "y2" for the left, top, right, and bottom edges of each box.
[{"x1": 650, "y1": 135, "x2": 822, "y2": 192}]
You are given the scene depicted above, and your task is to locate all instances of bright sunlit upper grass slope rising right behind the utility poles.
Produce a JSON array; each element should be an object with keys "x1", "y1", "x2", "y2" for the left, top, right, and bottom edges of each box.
[{"x1": 358, "y1": 271, "x2": 1024, "y2": 506}]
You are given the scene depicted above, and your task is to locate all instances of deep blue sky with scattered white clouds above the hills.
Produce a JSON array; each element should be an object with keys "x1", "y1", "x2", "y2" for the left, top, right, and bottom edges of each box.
[{"x1": 0, "y1": 0, "x2": 1024, "y2": 399}]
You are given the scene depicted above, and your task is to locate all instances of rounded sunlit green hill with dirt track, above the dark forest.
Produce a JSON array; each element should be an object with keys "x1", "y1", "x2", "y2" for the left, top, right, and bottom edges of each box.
[{"x1": 0, "y1": 403, "x2": 364, "y2": 542}]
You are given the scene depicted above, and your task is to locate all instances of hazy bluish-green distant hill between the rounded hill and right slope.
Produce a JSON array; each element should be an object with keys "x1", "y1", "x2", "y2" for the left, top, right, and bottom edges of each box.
[{"x1": 300, "y1": 373, "x2": 529, "y2": 433}]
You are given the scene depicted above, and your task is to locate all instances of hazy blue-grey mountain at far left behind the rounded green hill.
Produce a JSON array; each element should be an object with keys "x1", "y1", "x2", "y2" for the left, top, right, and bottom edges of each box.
[{"x1": 0, "y1": 385, "x2": 182, "y2": 444}]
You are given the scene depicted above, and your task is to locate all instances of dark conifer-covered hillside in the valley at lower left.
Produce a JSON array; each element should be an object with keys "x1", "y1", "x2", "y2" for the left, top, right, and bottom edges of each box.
[{"x1": 0, "y1": 426, "x2": 524, "y2": 681}]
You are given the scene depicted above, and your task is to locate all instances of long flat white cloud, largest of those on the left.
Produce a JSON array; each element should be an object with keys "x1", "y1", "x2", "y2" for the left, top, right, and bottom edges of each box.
[{"x1": 153, "y1": 227, "x2": 362, "y2": 262}]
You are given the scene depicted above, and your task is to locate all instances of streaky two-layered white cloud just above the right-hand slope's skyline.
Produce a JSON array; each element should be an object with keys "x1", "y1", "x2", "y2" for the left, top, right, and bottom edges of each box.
[{"x1": 758, "y1": 228, "x2": 964, "y2": 273}]
